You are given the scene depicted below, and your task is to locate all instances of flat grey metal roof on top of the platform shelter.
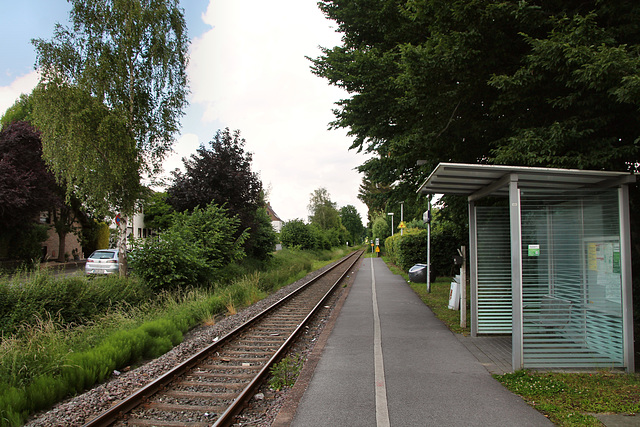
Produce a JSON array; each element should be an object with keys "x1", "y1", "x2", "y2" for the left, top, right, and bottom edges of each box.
[{"x1": 418, "y1": 163, "x2": 636, "y2": 200}]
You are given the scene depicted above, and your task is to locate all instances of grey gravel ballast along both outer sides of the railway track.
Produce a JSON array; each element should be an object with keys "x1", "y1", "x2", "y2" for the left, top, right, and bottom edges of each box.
[{"x1": 26, "y1": 258, "x2": 355, "y2": 427}]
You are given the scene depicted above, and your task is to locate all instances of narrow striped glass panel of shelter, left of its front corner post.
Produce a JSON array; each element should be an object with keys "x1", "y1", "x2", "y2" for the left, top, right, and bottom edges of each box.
[{"x1": 476, "y1": 206, "x2": 512, "y2": 334}]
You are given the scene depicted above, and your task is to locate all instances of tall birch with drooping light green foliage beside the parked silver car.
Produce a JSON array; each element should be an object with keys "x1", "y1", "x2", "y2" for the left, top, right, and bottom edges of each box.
[{"x1": 33, "y1": 0, "x2": 188, "y2": 274}]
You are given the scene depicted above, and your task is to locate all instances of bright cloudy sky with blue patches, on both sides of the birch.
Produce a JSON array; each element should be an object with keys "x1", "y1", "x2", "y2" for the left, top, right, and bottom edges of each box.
[{"x1": 0, "y1": 0, "x2": 366, "y2": 225}]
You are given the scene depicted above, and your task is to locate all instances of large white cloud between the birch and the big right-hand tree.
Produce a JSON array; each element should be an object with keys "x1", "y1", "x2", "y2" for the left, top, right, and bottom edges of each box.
[{"x1": 181, "y1": 0, "x2": 366, "y2": 221}]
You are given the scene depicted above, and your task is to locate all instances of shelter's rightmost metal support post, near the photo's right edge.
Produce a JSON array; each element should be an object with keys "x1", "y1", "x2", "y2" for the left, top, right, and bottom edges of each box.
[{"x1": 618, "y1": 185, "x2": 635, "y2": 372}]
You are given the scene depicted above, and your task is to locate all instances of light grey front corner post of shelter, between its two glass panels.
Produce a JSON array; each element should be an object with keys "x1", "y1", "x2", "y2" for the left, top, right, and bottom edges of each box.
[{"x1": 509, "y1": 173, "x2": 523, "y2": 371}]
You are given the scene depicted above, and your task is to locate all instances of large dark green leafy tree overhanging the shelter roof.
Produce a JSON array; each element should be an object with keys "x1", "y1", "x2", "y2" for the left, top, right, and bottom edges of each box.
[{"x1": 312, "y1": 0, "x2": 640, "y2": 212}]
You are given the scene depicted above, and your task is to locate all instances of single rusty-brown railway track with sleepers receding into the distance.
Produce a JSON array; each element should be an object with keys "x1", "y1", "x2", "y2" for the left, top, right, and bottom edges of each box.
[{"x1": 85, "y1": 252, "x2": 362, "y2": 427}]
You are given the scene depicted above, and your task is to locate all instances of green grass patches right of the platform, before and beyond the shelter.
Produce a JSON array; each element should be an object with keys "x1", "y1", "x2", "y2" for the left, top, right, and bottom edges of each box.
[{"x1": 383, "y1": 257, "x2": 640, "y2": 426}]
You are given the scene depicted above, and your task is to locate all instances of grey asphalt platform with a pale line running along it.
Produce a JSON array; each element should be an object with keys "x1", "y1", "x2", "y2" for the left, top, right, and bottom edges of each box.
[{"x1": 291, "y1": 258, "x2": 552, "y2": 427}]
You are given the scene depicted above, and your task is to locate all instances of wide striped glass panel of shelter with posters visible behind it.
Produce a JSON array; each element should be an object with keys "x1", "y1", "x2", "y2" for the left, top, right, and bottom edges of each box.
[{"x1": 521, "y1": 190, "x2": 623, "y2": 368}]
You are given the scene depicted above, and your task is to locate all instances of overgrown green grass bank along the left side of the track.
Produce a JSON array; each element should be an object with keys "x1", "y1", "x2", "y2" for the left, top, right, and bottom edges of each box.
[{"x1": 0, "y1": 247, "x2": 350, "y2": 426}]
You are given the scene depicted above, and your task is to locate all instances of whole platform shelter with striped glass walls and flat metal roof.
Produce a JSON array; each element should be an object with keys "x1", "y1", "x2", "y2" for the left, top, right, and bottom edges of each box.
[{"x1": 419, "y1": 163, "x2": 635, "y2": 372}]
